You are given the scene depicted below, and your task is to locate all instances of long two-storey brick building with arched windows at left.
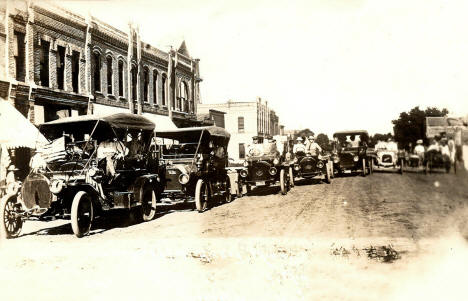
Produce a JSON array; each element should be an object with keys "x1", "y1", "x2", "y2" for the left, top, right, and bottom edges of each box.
[{"x1": 0, "y1": 1, "x2": 201, "y2": 127}]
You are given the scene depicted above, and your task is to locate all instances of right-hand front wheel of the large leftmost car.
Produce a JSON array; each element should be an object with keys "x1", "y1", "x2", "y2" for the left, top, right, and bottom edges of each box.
[{"x1": 71, "y1": 191, "x2": 94, "y2": 237}]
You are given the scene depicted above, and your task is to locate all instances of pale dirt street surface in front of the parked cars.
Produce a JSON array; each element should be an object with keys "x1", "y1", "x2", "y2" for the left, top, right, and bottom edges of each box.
[{"x1": 0, "y1": 173, "x2": 468, "y2": 301}]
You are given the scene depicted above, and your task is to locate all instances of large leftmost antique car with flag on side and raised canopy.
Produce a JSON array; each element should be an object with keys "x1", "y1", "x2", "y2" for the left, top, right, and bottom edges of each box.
[{"x1": 0, "y1": 113, "x2": 161, "y2": 238}]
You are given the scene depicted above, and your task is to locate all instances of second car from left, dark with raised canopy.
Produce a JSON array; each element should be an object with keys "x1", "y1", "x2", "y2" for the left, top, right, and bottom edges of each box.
[{"x1": 156, "y1": 126, "x2": 232, "y2": 212}]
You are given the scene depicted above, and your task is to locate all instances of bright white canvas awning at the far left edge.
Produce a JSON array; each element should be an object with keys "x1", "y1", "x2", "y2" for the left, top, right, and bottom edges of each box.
[{"x1": 0, "y1": 98, "x2": 47, "y2": 148}]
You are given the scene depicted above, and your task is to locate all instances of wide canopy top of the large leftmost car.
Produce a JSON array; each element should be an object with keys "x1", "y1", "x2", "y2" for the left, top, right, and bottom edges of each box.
[{"x1": 39, "y1": 113, "x2": 155, "y2": 139}]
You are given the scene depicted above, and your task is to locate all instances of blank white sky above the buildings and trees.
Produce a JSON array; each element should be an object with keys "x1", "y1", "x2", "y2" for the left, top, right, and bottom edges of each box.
[{"x1": 55, "y1": 0, "x2": 468, "y2": 135}]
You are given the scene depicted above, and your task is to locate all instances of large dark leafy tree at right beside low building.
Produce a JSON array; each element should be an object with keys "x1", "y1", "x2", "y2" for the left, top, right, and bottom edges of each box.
[{"x1": 392, "y1": 106, "x2": 448, "y2": 149}]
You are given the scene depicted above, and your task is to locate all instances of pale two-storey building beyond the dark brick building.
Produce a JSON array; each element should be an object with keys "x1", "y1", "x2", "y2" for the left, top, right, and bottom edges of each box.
[{"x1": 198, "y1": 98, "x2": 281, "y2": 162}]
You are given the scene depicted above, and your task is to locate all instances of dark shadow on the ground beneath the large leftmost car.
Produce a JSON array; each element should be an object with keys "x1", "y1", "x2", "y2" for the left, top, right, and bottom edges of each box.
[{"x1": 20, "y1": 202, "x2": 194, "y2": 237}]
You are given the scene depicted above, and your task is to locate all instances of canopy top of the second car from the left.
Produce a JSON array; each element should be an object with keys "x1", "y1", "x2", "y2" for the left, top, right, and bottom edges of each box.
[{"x1": 156, "y1": 126, "x2": 231, "y2": 145}]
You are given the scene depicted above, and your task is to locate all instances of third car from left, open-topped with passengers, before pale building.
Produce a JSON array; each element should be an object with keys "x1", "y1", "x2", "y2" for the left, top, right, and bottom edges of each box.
[{"x1": 238, "y1": 137, "x2": 292, "y2": 195}]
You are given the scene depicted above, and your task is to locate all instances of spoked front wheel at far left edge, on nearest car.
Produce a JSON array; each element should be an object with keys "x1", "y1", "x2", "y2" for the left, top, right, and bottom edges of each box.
[{"x1": 0, "y1": 194, "x2": 23, "y2": 238}]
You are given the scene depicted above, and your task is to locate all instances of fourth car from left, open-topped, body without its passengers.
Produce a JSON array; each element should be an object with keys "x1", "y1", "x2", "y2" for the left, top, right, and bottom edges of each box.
[{"x1": 291, "y1": 152, "x2": 333, "y2": 184}]
